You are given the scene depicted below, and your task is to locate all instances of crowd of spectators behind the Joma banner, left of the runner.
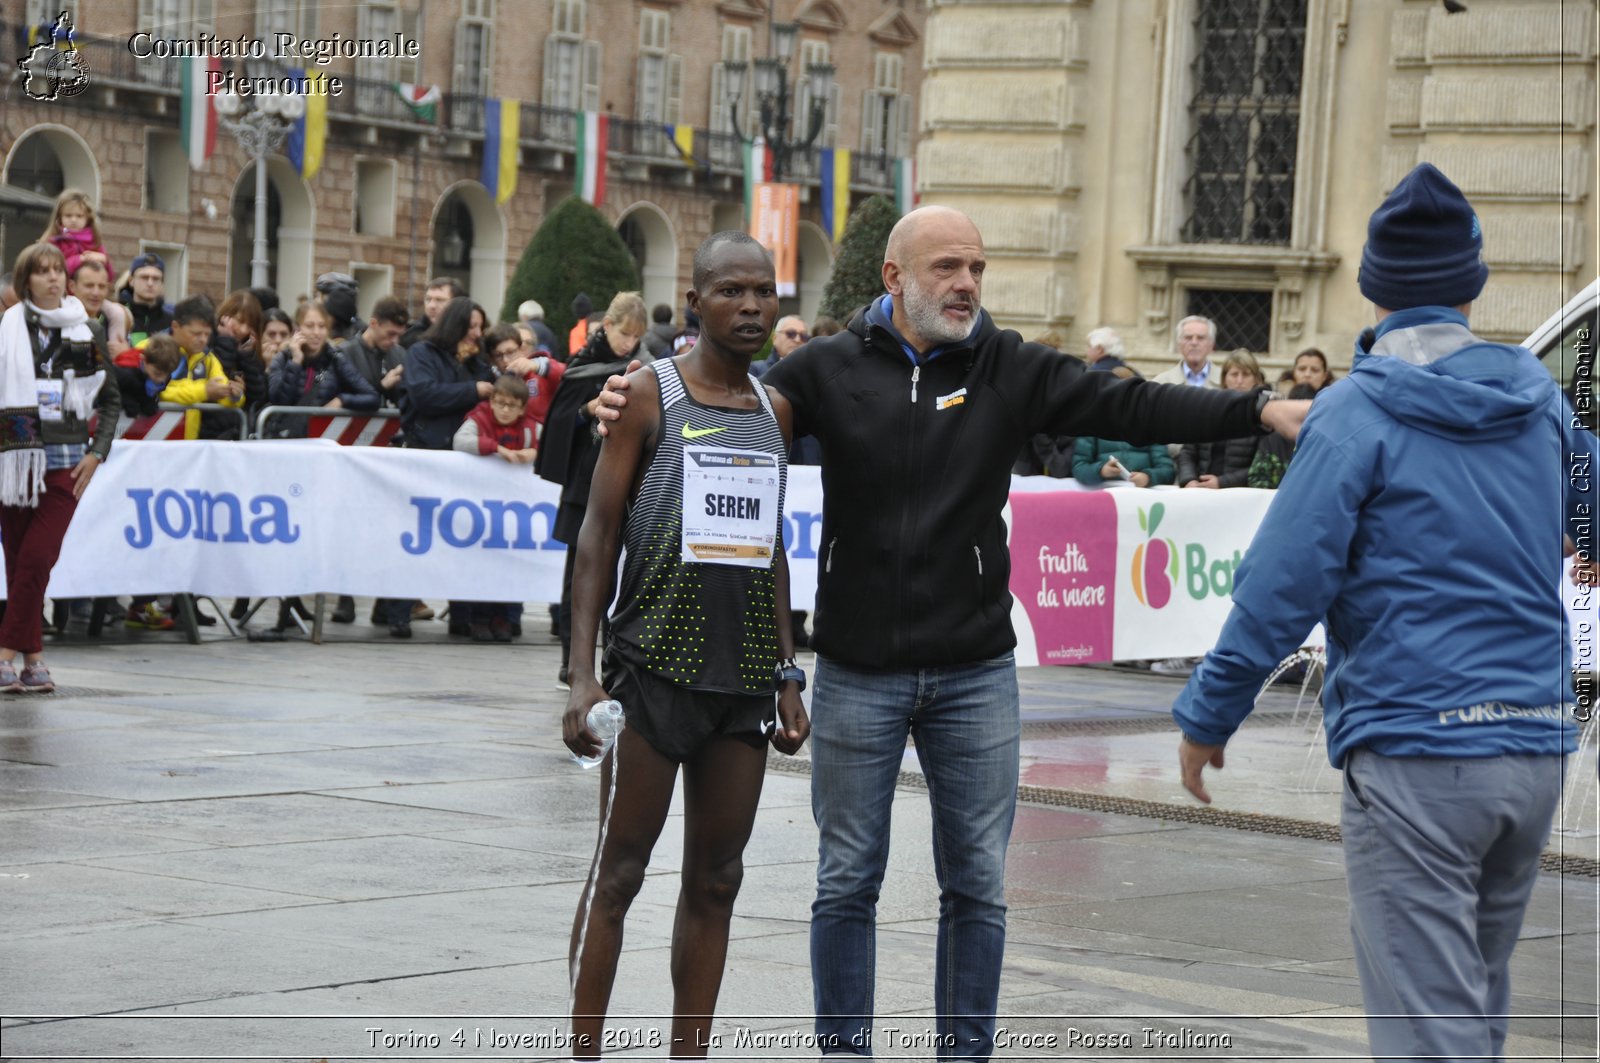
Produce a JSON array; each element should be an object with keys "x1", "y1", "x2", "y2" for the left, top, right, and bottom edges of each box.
[{"x1": 20, "y1": 191, "x2": 713, "y2": 642}]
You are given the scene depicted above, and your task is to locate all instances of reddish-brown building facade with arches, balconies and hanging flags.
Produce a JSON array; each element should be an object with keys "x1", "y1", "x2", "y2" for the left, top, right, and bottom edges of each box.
[{"x1": 0, "y1": 0, "x2": 926, "y2": 317}]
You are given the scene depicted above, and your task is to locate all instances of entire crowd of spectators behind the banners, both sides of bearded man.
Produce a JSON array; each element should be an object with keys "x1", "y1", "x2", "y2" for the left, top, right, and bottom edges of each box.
[{"x1": 21, "y1": 191, "x2": 1333, "y2": 665}]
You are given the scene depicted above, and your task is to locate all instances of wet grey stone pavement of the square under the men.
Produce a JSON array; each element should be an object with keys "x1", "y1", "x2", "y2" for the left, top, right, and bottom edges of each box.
[{"x1": 0, "y1": 602, "x2": 1600, "y2": 1063}]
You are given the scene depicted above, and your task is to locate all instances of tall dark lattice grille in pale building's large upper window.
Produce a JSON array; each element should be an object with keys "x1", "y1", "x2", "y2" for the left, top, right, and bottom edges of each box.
[{"x1": 1182, "y1": 0, "x2": 1306, "y2": 244}]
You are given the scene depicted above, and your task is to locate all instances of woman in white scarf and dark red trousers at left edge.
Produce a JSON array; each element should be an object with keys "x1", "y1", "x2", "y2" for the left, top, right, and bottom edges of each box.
[{"x1": 0, "y1": 243, "x2": 122, "y2": 693}]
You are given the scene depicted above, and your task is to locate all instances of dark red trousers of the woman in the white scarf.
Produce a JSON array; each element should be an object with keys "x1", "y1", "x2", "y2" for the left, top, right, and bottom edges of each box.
[{"x1": 0, "y1": 469, "x2": 78, "y2": 653}]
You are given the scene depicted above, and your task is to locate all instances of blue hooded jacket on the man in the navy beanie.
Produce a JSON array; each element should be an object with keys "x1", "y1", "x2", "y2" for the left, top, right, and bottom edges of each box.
[{"x1": 1173, "y1": 306, "x2": 1600, "y2": 767}]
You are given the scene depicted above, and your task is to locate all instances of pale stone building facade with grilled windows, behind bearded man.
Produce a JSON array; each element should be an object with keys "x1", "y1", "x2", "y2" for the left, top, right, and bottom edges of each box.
[{"x1": 918, "y1": 0, "x2": 1600, "y2": 376}]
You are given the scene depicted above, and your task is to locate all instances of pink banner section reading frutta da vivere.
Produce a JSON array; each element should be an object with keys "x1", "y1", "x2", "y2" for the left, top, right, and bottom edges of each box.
[{"x1": 1010, "y1": 493, "x2": 1117, "y2": 664}]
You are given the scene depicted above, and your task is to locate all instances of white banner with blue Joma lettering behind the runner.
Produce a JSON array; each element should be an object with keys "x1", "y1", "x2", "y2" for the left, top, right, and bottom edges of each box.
[{"x1": 12, "y1": 440, "x2": 822, "y2": 604}]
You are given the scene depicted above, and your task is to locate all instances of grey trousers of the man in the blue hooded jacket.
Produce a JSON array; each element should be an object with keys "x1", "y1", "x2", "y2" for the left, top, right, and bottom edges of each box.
[{"x1": 1341, "y1": 749, "x2": 1565, "y2": 1060}]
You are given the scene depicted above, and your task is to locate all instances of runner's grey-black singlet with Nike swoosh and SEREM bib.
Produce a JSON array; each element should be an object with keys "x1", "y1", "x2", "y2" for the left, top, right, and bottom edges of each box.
[{"x1": 610, "y1": 359, "x2": 789, "y2": 693}]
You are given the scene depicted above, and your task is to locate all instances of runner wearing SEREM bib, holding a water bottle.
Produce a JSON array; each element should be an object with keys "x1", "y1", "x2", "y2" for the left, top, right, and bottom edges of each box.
[{"x1": 562, "y1": 232, "x2": 810, "y2": 1058}]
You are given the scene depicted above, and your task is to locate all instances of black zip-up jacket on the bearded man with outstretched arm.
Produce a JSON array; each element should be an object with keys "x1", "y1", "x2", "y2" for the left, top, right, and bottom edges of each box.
[{"x1": 763, "y1": 299, "x2": 1259, "y2": 669}]
